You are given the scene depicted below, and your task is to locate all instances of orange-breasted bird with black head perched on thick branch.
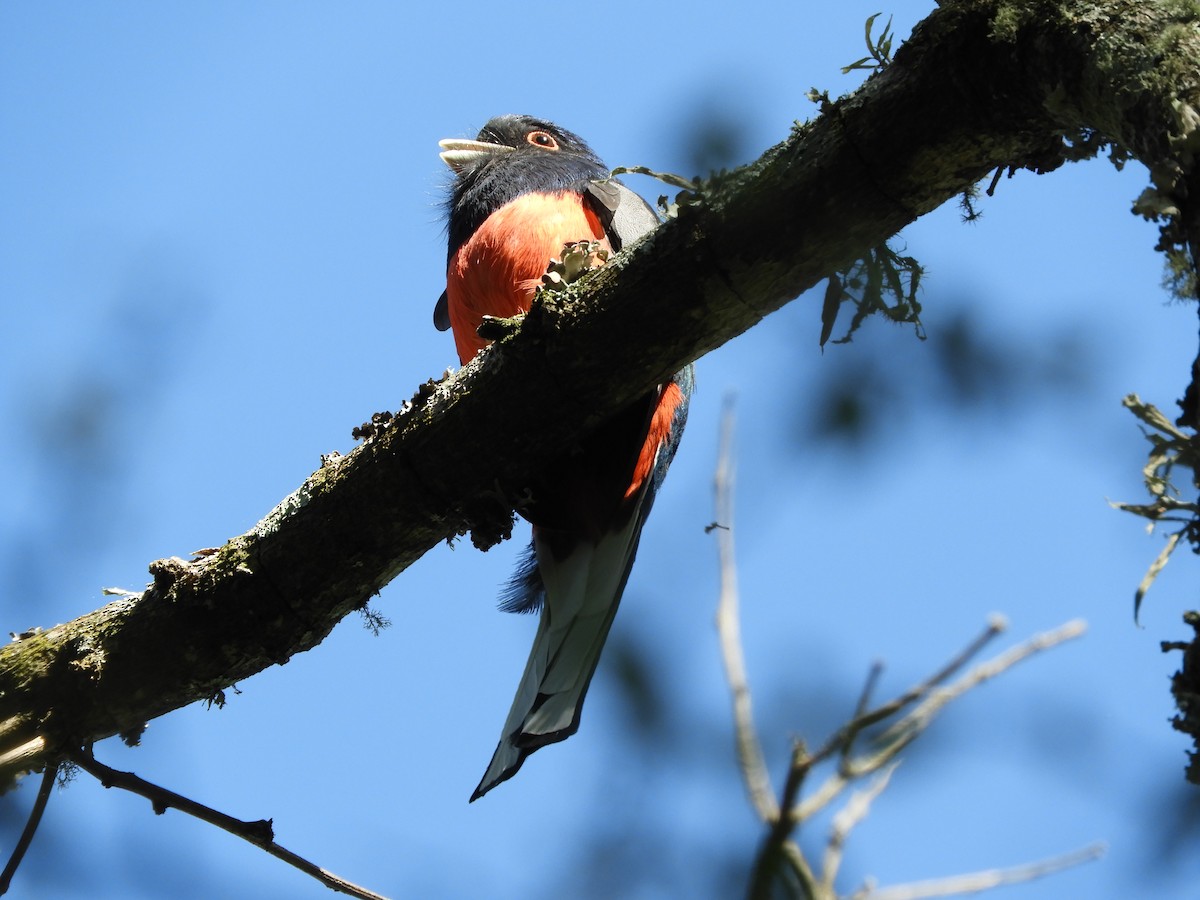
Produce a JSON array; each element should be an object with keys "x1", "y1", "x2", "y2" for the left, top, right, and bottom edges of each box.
[{"x1": 433, "y1": 115, "x2": 694, "y2": 802}]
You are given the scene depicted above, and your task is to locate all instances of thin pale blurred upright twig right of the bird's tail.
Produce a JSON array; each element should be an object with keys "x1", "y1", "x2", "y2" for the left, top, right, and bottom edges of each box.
[{"x1": 713, "y1": 401, "x2": 779, "y2": 823}]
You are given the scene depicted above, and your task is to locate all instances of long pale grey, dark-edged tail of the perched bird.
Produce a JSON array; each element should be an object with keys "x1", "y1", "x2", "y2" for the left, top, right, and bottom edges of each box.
[{"x1": 470, "y1": 513, "x2": 647, "y2": 800}]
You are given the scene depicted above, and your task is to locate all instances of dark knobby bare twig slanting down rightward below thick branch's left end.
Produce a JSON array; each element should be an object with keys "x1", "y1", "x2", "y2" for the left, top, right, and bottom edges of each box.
[{"x1": 68, "y1": 748, "x2": 386, "y2": 900}]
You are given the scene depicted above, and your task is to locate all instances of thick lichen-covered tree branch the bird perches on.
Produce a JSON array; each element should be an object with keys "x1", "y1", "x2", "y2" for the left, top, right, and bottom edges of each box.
[{"x1": 0, "y1": 0, "x2": 1200, "y2": 786}]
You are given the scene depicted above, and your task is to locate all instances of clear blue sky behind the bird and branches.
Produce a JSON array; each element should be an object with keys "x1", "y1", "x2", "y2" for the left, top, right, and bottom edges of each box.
[{"x1": 0, "y1": 0, "x2": 1200, "y2": 899}]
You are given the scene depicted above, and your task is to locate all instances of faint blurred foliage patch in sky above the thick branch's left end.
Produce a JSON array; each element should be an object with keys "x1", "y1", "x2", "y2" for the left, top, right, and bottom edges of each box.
[{"x1": 0, "y1": 254, "x2": 206, "y2": 624}]
